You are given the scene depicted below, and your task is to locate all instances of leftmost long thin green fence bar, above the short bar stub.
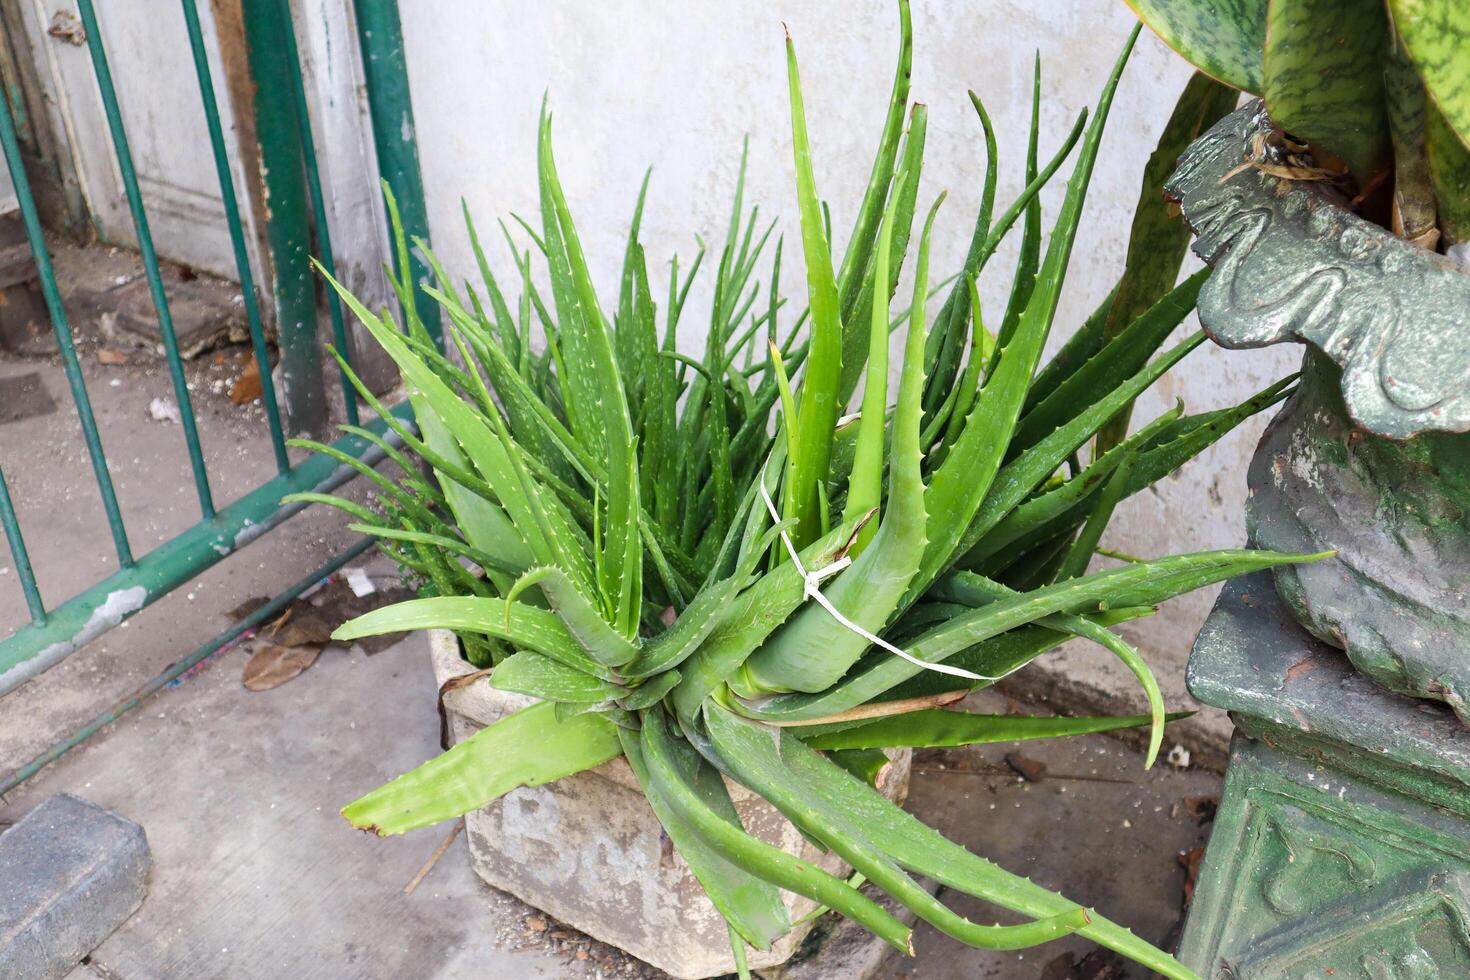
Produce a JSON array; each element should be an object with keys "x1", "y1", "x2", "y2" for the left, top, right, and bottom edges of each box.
[{"x1": 0, "y1": 91, "x2": 132, "y2": 569}]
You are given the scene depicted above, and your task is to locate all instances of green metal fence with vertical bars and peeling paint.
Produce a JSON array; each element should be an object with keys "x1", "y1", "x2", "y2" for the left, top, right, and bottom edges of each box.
[{"x1": 0, "y1": 0, "x2": 428, "y2": 793}]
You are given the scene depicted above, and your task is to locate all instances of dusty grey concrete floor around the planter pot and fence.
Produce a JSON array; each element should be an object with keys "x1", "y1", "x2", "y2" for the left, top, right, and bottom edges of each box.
[{"x1": 0, "y1": 239, "x2": 1219, "y2": 980}]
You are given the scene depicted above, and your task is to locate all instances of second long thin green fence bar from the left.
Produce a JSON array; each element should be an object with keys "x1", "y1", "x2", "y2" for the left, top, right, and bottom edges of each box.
[{"x1": 76, "y1": 0, "x2": 215, "y2": 520}]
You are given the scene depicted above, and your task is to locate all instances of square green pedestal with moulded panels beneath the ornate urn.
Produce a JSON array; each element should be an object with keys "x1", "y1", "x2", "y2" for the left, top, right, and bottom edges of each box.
[{"x1": 1179, "y1": 574, "x2": 1470, "y2": 980}]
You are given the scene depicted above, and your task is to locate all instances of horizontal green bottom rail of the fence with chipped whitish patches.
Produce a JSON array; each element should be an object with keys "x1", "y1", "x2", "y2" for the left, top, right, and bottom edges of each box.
[{"x1": 0, "y1": 403, "x2": 412, "y2": 693}]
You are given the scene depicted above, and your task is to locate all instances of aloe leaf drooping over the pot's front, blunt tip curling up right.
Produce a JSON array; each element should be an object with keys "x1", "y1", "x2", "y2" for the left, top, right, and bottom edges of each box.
[{"x1": 704, "y1": 704, "x2": 1088, "y2": 949}]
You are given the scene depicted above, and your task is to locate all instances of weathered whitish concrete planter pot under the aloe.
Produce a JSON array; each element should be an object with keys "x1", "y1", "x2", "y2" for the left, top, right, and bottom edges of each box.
[{"x1": 429, "y1": 630, "x2": 911, "y2": 980}]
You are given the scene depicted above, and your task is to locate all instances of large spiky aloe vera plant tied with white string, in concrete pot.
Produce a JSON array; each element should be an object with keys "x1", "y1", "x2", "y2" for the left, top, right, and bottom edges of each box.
[{"x1": 301, "y1": 11, "x2": 1310, "y2": 977}]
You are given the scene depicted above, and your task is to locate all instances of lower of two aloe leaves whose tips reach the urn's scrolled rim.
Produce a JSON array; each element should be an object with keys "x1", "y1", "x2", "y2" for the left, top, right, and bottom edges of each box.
[{"x1": 951, "y1": 332, "x2": 1204, "y2": 555}]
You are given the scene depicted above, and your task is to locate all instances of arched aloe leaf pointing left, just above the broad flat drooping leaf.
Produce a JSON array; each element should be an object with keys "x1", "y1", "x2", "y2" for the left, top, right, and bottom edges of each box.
[{"x1": 332, "y1": 595, "x2": 609, "y2": 679}]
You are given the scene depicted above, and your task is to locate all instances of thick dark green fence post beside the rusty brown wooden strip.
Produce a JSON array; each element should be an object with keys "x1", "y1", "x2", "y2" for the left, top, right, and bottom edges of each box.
[{"x1": 243, "y1": 0, "x2": 326, "y2": 435}]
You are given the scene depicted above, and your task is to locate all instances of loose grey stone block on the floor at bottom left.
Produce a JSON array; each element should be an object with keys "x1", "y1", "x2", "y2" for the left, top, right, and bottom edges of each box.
[{"x1": 0, "y1": 793, "x2": 151, "y2": 980}]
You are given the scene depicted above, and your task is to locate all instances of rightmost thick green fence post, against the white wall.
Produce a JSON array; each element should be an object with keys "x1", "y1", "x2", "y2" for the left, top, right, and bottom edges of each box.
[{"x1": 353, "y1": 0, "x2": 442, "y2": 347}]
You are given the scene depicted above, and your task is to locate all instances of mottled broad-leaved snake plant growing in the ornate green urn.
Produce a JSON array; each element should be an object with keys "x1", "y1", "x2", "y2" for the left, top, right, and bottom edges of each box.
[{"x1": 1126, "y1": 0, "x2": 1470, "y2": 248}]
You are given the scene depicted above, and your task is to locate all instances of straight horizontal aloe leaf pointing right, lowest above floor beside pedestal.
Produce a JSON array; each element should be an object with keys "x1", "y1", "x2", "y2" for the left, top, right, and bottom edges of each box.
[{"x1": 792, "y1": 708, "x2": 1194, "y2": 752}]
